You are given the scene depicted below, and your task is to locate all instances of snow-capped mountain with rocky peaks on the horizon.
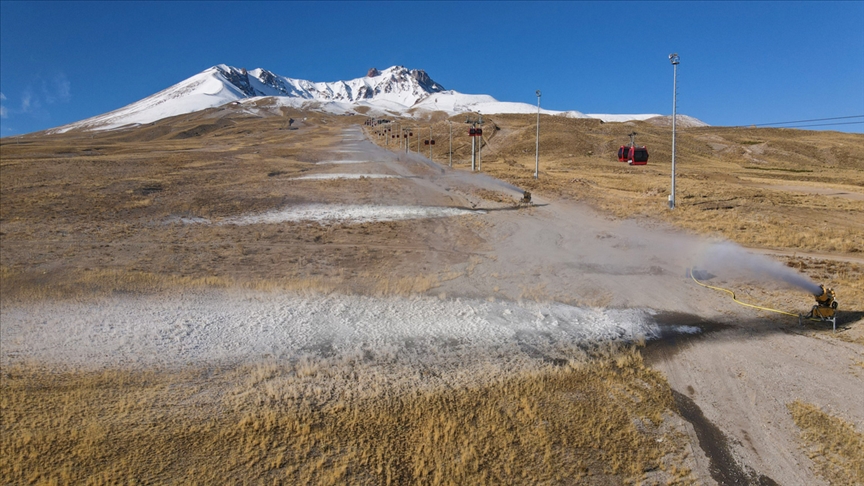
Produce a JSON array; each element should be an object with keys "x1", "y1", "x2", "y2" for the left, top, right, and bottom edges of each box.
[{"x1": 51, "y1": 64, "x2": 704, "y2": 133}]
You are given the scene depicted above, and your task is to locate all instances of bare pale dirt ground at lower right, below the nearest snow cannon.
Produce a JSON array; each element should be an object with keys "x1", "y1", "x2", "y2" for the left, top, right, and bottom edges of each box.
[{"x1": 648, "y1": 316, "x2": 864, "y2": 485}]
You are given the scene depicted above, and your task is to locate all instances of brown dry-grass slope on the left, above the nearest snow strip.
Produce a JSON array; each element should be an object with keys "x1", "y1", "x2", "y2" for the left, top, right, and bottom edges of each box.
[{"x1": 0, "y1": 110, "x2": 478, "y2": 300}]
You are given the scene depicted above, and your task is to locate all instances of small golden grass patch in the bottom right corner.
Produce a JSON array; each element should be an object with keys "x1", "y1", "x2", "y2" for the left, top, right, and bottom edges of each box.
[{"x1": 787, "y1": 401, "x2": 864, "y2": 485}]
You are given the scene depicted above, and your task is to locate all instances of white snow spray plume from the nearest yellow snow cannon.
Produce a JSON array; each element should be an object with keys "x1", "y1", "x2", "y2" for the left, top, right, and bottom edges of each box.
[{"x1": 702, "y1": 242, "x2": 822, "y2": 295}]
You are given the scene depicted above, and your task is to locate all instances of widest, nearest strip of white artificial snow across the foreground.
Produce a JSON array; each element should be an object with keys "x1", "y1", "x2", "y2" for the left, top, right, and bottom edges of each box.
[{"x1": 2, "y1": 290, "x2": 659, "y2": 367}]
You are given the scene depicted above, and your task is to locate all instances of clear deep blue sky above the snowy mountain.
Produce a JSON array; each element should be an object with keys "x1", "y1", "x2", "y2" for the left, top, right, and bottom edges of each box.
[{"x1": 0, "y1": 1, "x2": 864, "y2": 136}]
